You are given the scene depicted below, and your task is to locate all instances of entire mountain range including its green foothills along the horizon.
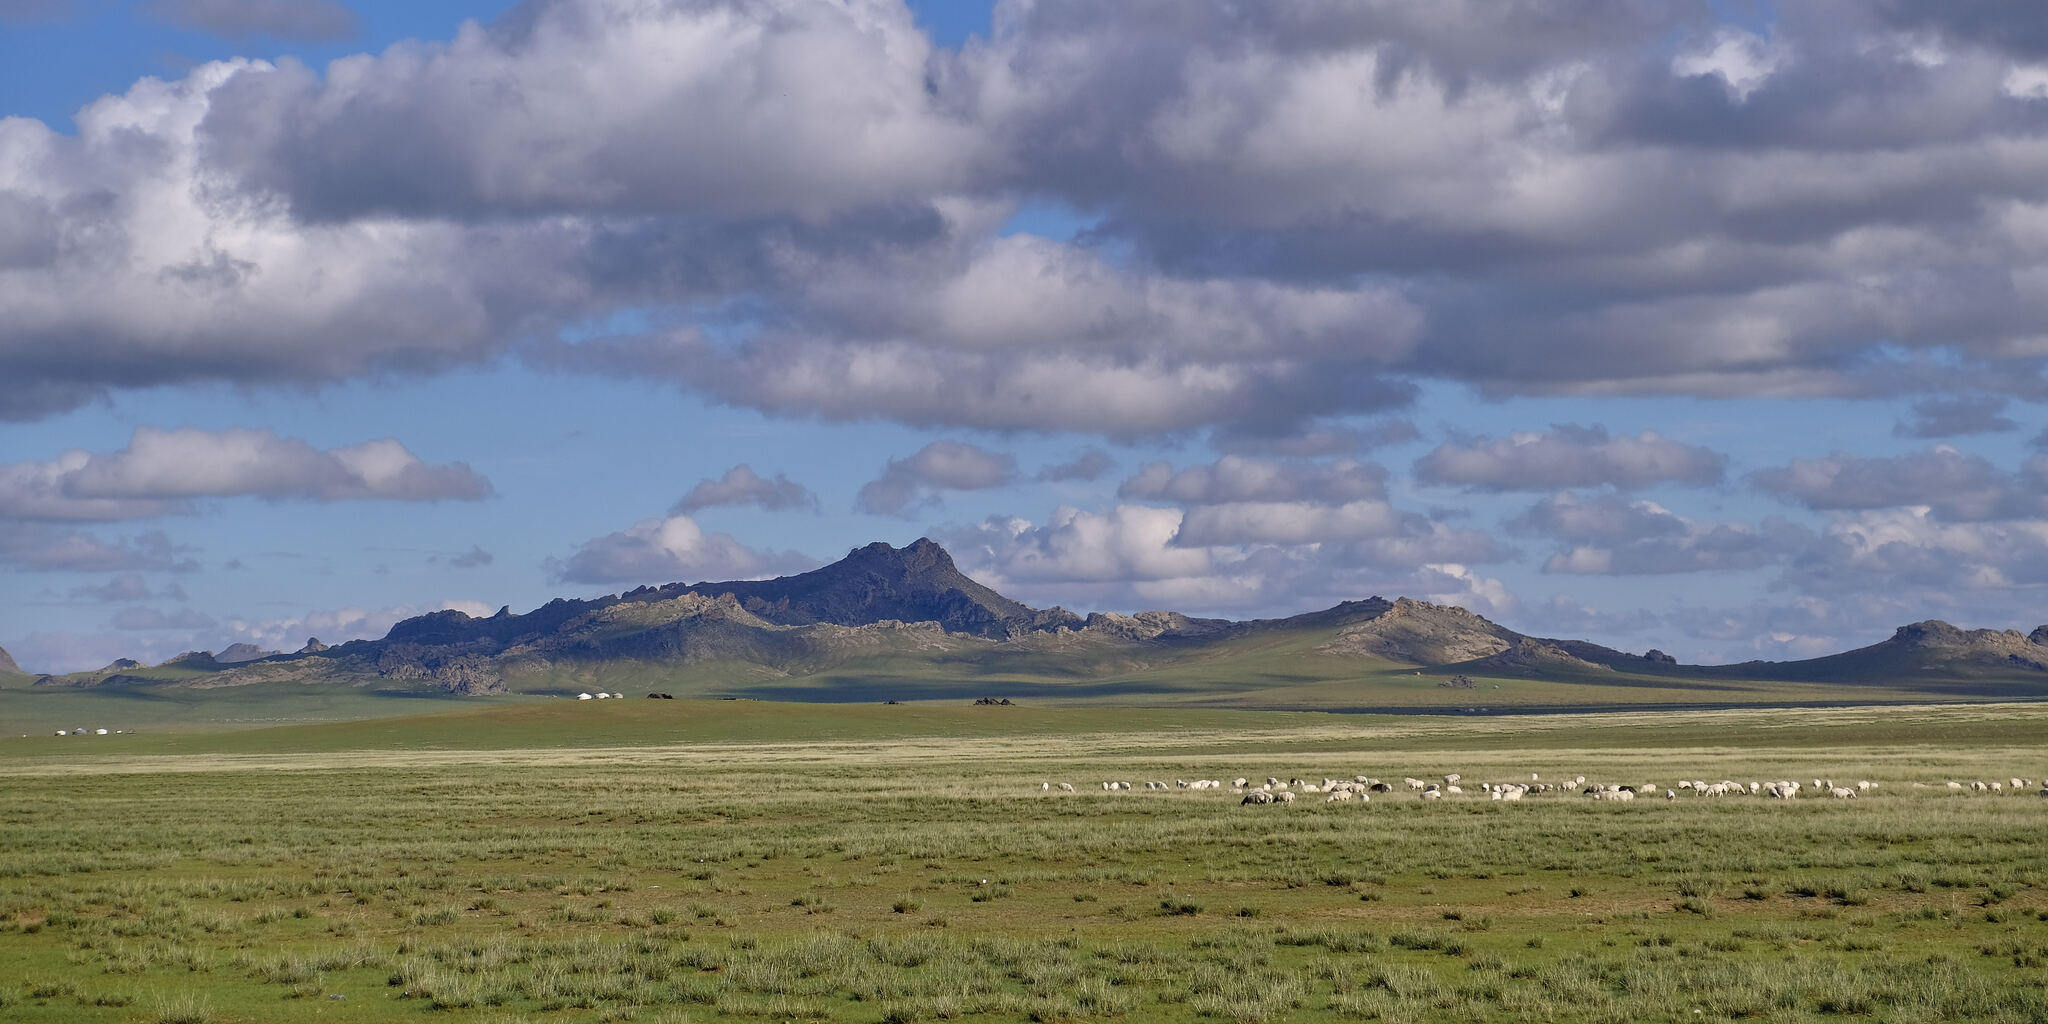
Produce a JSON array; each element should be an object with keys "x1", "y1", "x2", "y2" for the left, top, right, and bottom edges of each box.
[{"x1": 16, "y1": 539, "x2": 2048, "y2": 707}]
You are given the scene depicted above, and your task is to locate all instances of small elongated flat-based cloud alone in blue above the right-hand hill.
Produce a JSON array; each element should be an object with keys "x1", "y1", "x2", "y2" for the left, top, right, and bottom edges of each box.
[{"x1": 1415, "y1": 424, "x2": 1726, "y2": 492}]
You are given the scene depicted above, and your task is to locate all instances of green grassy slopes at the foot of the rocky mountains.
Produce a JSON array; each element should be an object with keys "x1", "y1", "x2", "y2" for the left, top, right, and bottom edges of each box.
[{"x1": 0, "y1": 610, "x2": 2048, "y2": 735}]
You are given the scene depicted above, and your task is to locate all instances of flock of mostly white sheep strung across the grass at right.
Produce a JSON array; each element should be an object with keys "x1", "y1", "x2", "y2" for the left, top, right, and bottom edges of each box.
[{"x1": 1038, "y1": 772, "x2": 2048, "y2": 805}]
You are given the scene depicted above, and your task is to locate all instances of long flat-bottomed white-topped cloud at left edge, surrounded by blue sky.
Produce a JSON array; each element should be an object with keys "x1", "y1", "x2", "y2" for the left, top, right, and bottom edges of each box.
[{"x1": 0, "y1": 426, "x2": 492, "y2": 522}]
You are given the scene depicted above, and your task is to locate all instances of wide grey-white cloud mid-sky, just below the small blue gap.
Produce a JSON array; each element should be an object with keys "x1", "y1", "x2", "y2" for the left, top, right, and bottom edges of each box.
[{"x1": 535, "y1": 232, "x2": 1419, "y2": 438}]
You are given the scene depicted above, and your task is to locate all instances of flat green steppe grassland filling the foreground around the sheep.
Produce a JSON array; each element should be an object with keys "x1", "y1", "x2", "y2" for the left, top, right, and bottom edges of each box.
[{"x1": 0, "y1": 707, "x2": 2048, "y2": 1022}]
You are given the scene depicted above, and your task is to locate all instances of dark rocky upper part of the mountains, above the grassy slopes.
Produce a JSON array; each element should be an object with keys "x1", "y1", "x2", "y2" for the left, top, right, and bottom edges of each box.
[{"x1": 36, "y1": 539, "x2": 2048, "y2": 692}]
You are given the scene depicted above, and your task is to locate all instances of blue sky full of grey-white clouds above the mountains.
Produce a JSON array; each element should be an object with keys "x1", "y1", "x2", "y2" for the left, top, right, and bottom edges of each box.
[{"x1": 0, "y1": 0, "x2": 2048, "y2": 672}]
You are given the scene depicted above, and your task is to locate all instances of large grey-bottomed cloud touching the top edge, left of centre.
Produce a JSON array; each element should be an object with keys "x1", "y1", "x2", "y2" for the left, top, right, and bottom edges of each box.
[{"x1": 205, "y1": 0, "x2": 993, "y2": 219}]
